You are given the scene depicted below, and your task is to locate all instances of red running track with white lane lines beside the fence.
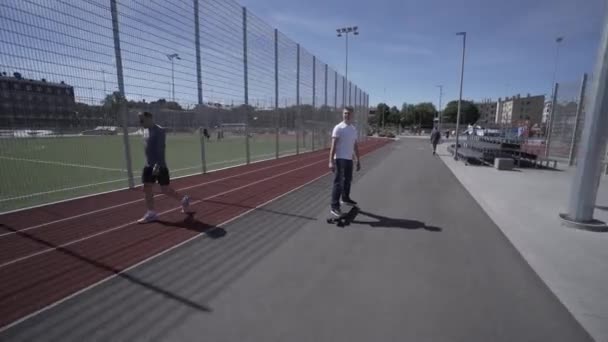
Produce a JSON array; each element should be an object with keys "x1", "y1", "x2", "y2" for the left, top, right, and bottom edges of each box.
[{"x1": 0, "y1": 139, "x2": 390, "y2": 327}]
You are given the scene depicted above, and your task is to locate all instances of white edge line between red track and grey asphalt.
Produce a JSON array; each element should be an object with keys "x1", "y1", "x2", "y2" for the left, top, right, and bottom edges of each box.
[{"x1": 0, "y1": 172, "x2": 329, "y2": 333}]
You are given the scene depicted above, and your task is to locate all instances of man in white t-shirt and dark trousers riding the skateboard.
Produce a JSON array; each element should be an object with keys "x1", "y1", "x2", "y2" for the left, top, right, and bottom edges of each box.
[{"x1": 329, "y1": 107, "x2": 361, "y2": 216}]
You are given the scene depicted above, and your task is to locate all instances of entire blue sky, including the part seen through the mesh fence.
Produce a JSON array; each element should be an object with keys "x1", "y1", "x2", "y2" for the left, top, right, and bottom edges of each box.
[{"x1": 0, "y1": 0, "x2": 605, "y2": 107}]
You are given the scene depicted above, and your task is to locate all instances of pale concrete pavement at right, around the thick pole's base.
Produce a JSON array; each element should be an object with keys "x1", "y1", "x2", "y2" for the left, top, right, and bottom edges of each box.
[{"x1": 438, "y1": 140, "x2": 608, "y2": 342}]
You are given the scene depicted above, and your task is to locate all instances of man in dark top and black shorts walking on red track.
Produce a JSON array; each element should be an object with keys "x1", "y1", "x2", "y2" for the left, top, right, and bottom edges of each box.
[{"x1": 137, "y1": 112, "x2": 190, "y2": 223}]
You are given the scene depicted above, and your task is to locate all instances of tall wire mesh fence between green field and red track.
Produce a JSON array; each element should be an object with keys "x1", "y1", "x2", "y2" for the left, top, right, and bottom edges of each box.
[{"x1": 0, "y1": 0, "x2": 369, "y2": 212}]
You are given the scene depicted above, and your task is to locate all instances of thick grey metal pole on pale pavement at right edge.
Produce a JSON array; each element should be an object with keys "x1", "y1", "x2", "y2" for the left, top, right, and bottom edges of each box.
[{"x1": 560, "y1": 9, "x2": 608, "y2": 230}]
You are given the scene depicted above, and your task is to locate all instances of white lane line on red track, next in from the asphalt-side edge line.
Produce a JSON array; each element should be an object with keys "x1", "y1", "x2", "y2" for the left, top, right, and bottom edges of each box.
[{"x1": 0, "y1": 159, "x2": 325, "y2": 268}]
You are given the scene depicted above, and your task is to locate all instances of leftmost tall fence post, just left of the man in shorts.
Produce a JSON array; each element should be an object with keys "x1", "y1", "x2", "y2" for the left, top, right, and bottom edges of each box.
[{"x1": 110, "y1": 0, "x2": 135, "y2": 188}]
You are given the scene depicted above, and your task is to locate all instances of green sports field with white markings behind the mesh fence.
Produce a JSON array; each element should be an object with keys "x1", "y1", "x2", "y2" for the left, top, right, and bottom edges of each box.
[{"x1": 0, "y1": 134, "x2": 319, "y2": 212}]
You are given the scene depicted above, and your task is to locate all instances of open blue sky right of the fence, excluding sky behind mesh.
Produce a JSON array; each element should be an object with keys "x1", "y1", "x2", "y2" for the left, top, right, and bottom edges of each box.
[{"x1": 240, "y1": 0, "x2": 604, "y2": 107}]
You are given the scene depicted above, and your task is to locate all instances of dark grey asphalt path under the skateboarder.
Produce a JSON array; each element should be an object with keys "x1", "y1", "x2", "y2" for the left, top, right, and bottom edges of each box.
[{"x1": 0, "y1": 139, "x2": 591, "y2": 342}]
